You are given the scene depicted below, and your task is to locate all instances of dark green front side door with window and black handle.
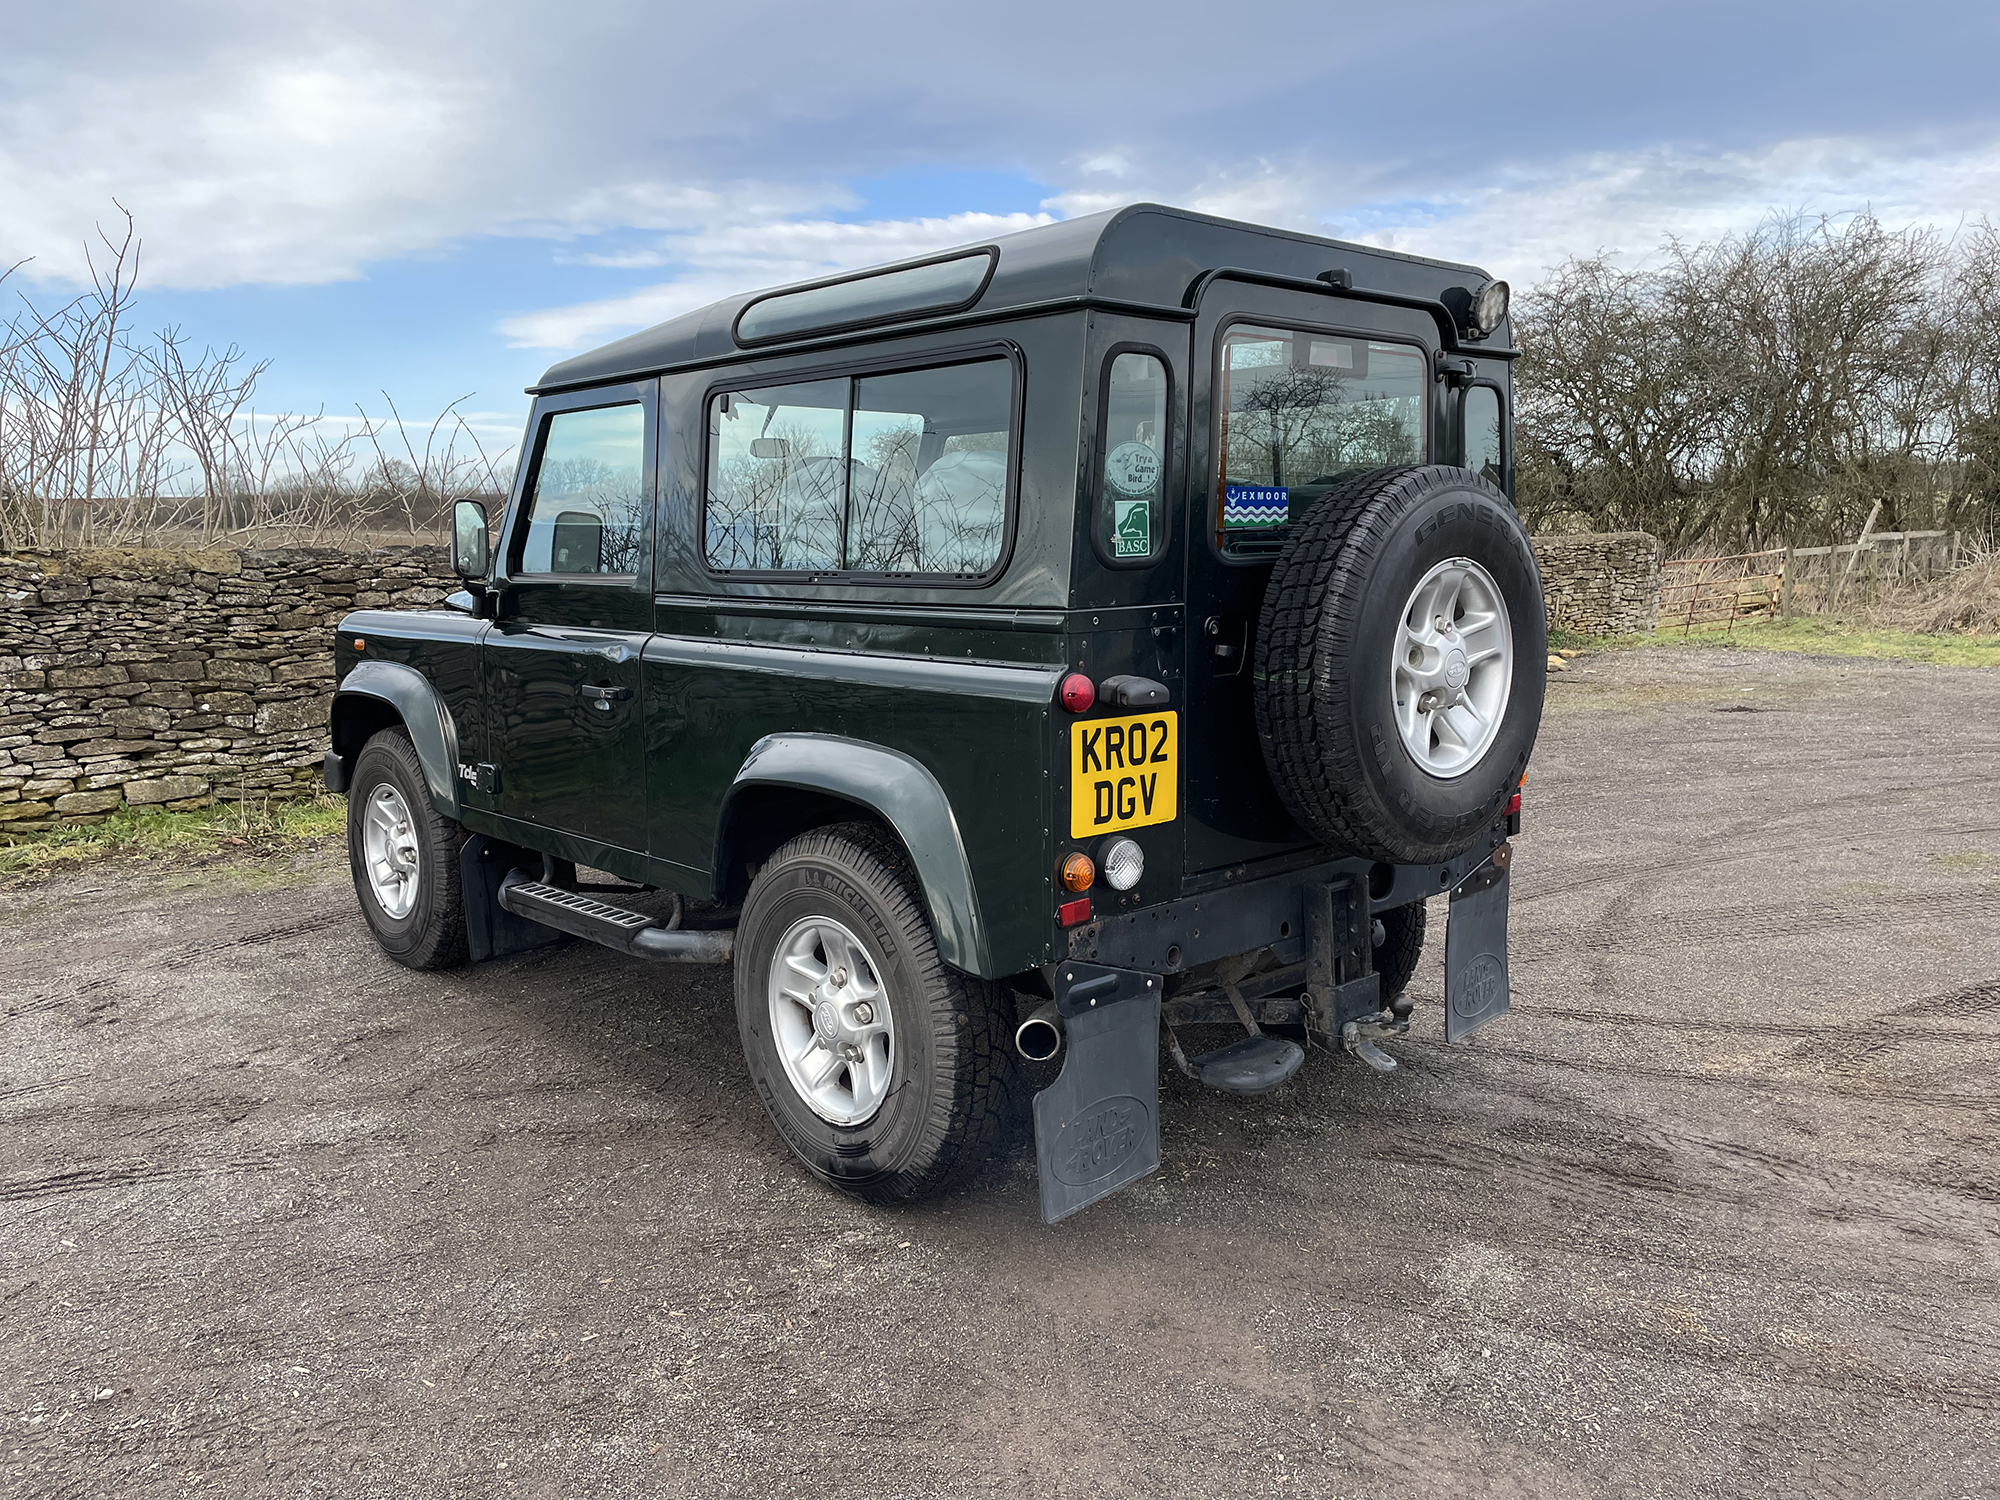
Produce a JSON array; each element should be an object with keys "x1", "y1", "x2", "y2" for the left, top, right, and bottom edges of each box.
[{"x1": 484, "y1": 382, "x2": 656, "y2": 850}]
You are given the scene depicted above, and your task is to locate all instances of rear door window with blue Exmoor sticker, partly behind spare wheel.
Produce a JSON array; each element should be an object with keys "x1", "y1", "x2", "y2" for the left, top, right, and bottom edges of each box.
[{"x1": 1216, "y1": 326, "x2": 1430, "y2": 556}]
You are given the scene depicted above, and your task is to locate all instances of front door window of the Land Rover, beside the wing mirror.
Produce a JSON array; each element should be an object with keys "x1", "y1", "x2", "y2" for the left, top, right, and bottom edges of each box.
[{"x1": 518, "y1": 404, "x2": 646, "y2": 574}]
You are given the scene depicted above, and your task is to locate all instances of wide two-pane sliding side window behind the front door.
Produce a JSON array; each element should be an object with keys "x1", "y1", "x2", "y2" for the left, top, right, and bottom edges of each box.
[{"x1": 702, "y1": 358, "x2": 1014, "y2": 578}]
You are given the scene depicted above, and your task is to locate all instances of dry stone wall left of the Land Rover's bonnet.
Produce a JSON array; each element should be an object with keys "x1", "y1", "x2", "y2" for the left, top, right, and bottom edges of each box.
[{"x1": 0, "y1": 546, "x2": 454, "y2": 834}]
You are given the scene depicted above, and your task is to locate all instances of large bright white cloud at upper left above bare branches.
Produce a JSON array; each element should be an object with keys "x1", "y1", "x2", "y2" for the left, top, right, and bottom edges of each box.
[{"x1": 0, "y1": 48, "x2": 490, "y2": 286}]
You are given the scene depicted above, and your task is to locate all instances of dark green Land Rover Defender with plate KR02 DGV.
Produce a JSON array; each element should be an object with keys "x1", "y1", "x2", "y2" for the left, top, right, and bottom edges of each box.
[{"x1": 326, "y1": 204, "x2": 1546, "y2": 1220}]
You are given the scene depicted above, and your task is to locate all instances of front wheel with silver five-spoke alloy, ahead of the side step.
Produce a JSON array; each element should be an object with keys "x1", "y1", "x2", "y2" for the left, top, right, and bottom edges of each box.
[{"x1": 348, "y1": 728, "x2": 466, "y2": 968}]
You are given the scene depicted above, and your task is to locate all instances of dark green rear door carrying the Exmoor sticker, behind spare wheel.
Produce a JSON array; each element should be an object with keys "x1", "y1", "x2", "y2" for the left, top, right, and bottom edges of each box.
[{"x1": 1182, "y1": 278, "x2": 1438, "y2": 884}]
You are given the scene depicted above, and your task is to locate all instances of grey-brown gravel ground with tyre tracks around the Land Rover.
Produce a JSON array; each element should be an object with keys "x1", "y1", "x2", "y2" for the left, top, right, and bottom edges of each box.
[{"x1": 0, "y1": 650, "x2": 2000, "y2": 1500}]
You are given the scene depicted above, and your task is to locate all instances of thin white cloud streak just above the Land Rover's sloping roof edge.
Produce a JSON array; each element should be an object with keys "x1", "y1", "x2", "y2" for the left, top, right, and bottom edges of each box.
[{"x1": 500, "y1": 214, "x2": 1054, "y2": 350}]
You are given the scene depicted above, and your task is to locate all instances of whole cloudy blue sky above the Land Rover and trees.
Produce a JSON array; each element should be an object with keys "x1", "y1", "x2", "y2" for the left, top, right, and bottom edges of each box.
[{"x1": 0, "y1": 0, "x2": 2000, "y2": 458}]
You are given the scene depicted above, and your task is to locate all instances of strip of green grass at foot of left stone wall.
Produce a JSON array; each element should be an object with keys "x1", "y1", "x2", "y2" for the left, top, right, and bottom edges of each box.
[{"x1": 0, "y1": 796, "x2": 348, "y2": 878}]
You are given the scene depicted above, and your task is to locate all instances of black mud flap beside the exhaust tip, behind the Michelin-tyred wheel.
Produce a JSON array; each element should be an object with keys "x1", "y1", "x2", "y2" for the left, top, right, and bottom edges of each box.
[{"x1": 1034, "y1": 964, "x2": 1160, "y2": 1224}]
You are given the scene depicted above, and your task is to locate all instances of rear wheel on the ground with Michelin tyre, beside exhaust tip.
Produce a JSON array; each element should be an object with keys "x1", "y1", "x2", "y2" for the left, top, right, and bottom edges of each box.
[{"x1": 736, "y1": 824, "x2": 1014, "y2": 1202}]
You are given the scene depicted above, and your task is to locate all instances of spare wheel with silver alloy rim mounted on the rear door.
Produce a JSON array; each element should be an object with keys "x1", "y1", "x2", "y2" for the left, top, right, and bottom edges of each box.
[{"x1": 1256, "y1": 466, "x2": 1548, "y2": 864}]
